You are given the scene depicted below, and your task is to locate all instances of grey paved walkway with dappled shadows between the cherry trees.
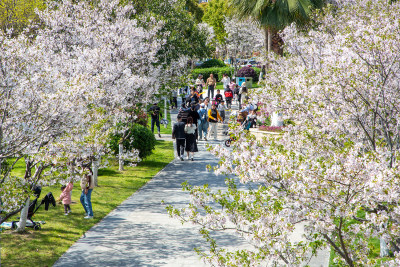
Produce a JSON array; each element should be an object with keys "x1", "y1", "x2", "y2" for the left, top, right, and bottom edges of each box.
[{"x1": 54, "y1": 101, "x2": 329, "y2": 267}]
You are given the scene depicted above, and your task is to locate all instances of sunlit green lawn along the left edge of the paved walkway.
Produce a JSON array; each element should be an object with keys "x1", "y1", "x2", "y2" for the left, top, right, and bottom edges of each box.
[{"x1": 0, "y1": 141, "x2": 174, "y2": 266}]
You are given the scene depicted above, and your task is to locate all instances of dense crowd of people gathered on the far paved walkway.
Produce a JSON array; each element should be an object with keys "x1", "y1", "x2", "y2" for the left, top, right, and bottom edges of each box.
[{"x1": 172, "y1": 74, "x2": 256, "y2": 161}]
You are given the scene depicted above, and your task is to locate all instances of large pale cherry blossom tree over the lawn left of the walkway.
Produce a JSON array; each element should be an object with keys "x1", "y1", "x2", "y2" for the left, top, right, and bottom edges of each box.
[{"x1": 0, "y1": 0, "x2": 177, "y2": 231}]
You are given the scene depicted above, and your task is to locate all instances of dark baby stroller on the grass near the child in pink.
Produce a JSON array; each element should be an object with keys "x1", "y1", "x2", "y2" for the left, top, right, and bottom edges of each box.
[{"x1": 11, "y1": 186, "x2": 56, "y2": 230}]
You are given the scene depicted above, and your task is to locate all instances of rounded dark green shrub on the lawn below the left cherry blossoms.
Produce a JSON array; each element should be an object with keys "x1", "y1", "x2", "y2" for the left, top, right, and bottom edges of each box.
[{"x1": 109, "y1": 124, "x2": 156, "y2": 159}]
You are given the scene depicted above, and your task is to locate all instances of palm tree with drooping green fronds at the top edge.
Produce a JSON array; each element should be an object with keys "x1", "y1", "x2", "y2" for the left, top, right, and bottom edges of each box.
[{"x1": 229, "y1": 0, "x2": 325, "y2": 54}]
